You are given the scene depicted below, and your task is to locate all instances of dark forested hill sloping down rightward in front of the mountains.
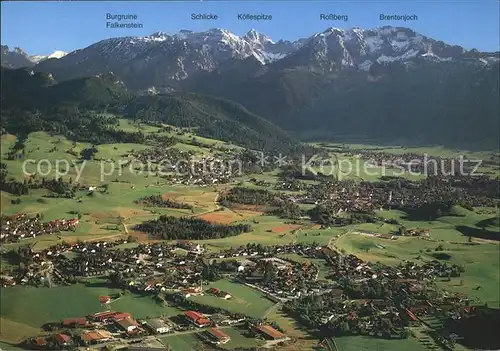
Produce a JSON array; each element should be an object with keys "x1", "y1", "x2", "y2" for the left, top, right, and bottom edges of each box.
[{"x1": 2, "y1": 69, "x2": 308, "y2": 152}]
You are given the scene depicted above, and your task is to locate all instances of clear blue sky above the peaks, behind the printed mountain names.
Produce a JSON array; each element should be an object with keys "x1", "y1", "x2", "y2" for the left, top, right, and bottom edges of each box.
[{"x1": 1, "y1": 0, "x2": 500, "y2": 55}]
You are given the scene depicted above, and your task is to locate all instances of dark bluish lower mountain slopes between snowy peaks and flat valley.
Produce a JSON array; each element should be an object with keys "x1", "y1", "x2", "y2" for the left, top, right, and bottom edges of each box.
[{"x1": 186, "y1": 59, "x2": 499, "y2": 148}]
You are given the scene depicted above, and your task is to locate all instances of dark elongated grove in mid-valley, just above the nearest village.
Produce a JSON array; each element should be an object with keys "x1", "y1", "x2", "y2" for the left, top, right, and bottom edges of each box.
[{"x1": 135, "y1": 216, "x2": 252, "y2": 240}]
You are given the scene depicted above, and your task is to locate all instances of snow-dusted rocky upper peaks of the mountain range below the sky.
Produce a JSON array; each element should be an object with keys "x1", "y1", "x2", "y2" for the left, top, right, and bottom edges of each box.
[{"x1": 10, "y1": 27, "x2": 498, "y2": 89}]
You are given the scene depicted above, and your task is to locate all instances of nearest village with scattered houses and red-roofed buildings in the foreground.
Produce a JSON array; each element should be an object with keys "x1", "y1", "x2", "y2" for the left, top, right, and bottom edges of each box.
[{"x1": 0, "y1": 232, "x2": 488, "y2": 350}]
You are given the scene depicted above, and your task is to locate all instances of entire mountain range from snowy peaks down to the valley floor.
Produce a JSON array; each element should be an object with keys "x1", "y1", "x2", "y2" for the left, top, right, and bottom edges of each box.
[{"x1": 2, "y1": 26, "x2": 499, "y2": 145}]
